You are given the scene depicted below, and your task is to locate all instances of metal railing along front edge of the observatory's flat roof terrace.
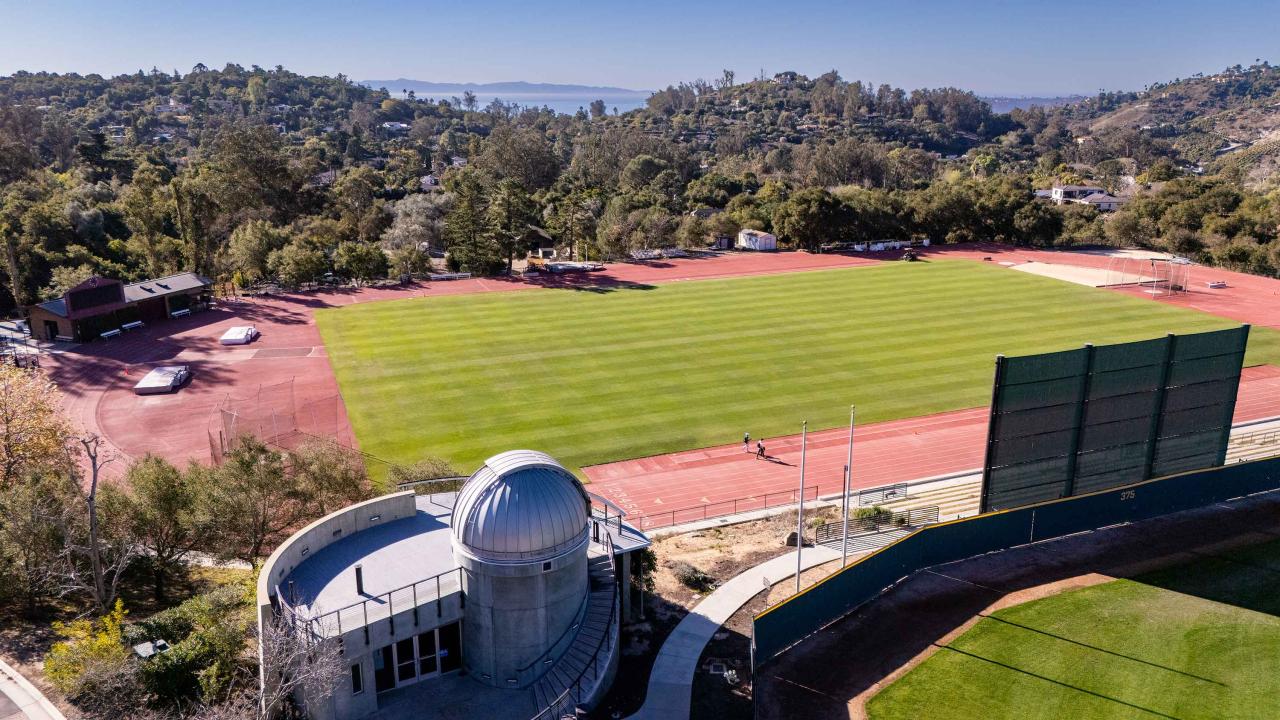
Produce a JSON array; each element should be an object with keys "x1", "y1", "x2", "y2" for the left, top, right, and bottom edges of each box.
[{"x1": 275, "y1": 568, "x2": 466, "y2": 644}]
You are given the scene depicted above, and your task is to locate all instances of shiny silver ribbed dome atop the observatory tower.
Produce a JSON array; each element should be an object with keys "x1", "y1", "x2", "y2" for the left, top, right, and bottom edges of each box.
[{"x1": 452, "y1": 450, "x2": 589, "y2": 564}]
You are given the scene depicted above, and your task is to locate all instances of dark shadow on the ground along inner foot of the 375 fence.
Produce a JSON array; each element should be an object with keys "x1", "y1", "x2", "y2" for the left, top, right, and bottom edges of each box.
[{"x1": 754, "y1": 493, "x2": 1280, "y2": 720}]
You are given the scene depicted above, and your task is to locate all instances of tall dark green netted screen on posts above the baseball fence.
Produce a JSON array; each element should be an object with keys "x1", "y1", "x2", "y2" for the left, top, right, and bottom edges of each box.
[{"x1": 982, "y1": 325, "x2": 1249, "y2": 512}]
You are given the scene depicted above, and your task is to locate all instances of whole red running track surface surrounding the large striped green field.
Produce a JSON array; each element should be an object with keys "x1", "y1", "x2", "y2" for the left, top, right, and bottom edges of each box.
[{"x1": 45, "y1": 245, "x2": 1280, "y2": 489}]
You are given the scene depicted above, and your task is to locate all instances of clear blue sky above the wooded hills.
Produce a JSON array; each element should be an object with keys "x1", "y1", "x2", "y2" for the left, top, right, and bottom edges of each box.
[{"x1": 0, "y1": 0, "x2": 1280, "y2": 95}]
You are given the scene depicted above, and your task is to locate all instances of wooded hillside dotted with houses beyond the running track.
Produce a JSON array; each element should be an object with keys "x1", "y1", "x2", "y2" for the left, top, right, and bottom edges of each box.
[{"x1": 0, "y1": 63, "x2": 1280, "y2": 316}]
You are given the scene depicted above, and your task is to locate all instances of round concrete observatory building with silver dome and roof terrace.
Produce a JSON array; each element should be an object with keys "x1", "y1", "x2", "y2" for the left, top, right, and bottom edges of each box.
[{"x1": 257, "y1": 450, "x2": 649, "y2": 720}]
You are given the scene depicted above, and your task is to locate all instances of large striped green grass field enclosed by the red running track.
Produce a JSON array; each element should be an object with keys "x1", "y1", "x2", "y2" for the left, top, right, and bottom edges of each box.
[{"x1": 316, "y1": 260, "x2": 1280, "y2": 471}]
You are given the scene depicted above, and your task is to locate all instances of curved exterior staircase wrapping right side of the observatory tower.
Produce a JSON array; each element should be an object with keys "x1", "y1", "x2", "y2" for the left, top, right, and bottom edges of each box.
[{"x1": 532, "y1": 552, "x2": 618, "y2": 720}]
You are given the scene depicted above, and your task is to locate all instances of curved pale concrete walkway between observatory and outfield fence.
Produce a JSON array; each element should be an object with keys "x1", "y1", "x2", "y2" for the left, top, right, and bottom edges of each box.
[{"x1": 631, "y1": 546, "x2": 840, "y2": 720}]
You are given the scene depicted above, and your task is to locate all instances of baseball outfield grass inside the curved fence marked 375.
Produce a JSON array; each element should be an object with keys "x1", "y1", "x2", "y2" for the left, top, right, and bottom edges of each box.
[{"x1": 867, "y1": 541, "x2": 1280, "y2": 720}]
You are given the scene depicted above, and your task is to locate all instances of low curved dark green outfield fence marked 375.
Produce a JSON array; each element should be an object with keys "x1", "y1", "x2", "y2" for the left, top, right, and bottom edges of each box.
[{"x1": 751, "y1": 457, "x2": 1280, "y2": 671}]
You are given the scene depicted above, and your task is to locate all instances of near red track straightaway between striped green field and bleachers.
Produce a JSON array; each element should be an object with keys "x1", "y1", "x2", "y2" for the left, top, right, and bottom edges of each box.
[{"x1": 582, "y1": 365, "x2": 1280, "y2": 528}]
